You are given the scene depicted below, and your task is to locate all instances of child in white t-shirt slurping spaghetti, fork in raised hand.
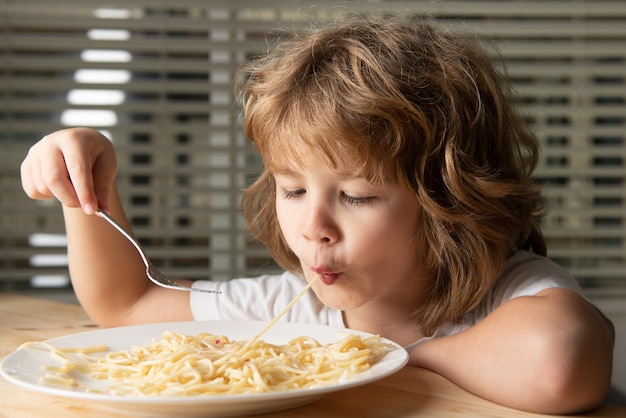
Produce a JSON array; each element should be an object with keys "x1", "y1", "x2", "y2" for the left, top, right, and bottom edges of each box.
[{"x1": 22, "y1": 15, "x2": 613, "y2": 413}]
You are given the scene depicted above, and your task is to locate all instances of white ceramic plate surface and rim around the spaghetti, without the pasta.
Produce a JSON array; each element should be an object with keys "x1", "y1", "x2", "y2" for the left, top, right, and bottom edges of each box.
[{"x1": 0, "y1": 321, "x2": 408, "y2": 417}]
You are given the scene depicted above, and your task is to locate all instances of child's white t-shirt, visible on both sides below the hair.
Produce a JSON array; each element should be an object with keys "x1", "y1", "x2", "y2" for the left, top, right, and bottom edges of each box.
[{"x1": 190, "y1": 251, "x2": 582, "y2": 351}]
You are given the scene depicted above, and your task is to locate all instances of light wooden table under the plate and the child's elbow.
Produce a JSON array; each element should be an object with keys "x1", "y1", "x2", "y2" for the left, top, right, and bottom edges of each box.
[{"x1": 0, "y1": 294, "x2": 626, "y2": 418}]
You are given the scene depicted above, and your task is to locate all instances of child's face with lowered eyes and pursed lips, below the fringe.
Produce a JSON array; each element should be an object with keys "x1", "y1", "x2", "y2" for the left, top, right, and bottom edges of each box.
[{"x1": 273, "y1": 153, "x2": 425, "y2": 311}]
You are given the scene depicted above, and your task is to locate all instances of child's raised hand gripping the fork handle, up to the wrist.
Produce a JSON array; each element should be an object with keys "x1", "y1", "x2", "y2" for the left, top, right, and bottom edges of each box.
[{"x1": 21, "y1": 128, "x2": 117, "y2": 214}]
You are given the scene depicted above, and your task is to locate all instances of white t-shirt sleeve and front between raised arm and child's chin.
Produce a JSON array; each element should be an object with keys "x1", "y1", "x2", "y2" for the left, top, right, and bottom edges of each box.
[{"x1": 190, "y1": 272, "x2": 342, "y2": 326}]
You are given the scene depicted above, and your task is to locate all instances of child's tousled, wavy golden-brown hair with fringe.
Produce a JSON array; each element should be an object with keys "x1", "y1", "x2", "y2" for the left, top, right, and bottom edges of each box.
[{"x1": 237, "y1": 17, "x2": 546, "y2": 334}]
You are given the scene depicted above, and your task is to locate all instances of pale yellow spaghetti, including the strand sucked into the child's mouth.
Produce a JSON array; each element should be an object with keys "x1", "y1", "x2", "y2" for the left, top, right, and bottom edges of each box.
[{"x1": 24, "y1": 279, "x2": 396, "y2": 396}]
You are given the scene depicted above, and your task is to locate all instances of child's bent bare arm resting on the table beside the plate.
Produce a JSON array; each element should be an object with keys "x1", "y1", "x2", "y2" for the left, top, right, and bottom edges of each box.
[{"x1": 411, "y1": 289, "x2": 614, "y2": 414}]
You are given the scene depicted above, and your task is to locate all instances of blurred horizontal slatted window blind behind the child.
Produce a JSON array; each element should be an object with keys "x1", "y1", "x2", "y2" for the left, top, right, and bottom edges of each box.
[{"x1": 0, "y1": 0, "x2": 626, "y2": 306}]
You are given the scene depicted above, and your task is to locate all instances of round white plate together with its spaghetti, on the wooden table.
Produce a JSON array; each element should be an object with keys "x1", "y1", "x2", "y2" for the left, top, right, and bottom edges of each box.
[{"x1": 0, "y1": 321, "x2": 408, "y2": 417}]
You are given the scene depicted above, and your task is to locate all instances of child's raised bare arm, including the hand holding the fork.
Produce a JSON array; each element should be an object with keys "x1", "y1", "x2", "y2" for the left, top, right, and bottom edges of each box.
[{"x1": 22, "y1": 128, "x2": 192, "y2": 326}]
